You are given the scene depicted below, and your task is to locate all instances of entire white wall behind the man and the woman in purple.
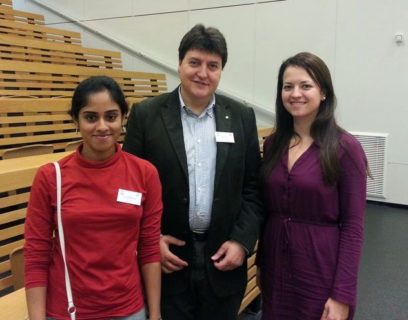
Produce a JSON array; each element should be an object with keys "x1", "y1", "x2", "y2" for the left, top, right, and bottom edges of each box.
[{"x1": 14, "y1": 0, "x2": 408, "y2": 205}]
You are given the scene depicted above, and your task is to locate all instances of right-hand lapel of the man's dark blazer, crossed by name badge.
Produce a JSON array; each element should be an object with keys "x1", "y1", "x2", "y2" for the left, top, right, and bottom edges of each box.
[{"x1": 214, "y1": 96, "x2": 231, "y2": 190}]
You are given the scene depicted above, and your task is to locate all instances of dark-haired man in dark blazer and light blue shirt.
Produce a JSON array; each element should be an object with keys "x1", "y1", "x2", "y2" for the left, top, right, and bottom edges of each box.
[{"x1": 123, "y1": 25, "x2": 262, "y2": 320}]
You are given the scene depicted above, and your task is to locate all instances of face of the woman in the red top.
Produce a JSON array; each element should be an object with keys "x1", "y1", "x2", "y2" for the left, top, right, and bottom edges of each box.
[{"x1": 75, "y1": 90, "x2": 122, "y2": 161}]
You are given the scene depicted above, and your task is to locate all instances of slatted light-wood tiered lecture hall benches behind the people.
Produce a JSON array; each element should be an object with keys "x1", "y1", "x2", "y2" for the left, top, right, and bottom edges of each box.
[{"x1": 0, "y1": 0, "x2": 271, "y2": 320}]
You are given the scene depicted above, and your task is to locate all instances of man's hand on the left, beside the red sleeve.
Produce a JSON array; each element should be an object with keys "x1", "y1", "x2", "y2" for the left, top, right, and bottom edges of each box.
[{"x1": 160, "y1": 236, "x2": 188, "y2": 273}]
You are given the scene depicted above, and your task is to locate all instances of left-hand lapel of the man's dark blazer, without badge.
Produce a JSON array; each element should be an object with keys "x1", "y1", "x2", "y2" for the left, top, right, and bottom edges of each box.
[{"x1": 161, "y1": 88, "x2": 188, "y2": 181}]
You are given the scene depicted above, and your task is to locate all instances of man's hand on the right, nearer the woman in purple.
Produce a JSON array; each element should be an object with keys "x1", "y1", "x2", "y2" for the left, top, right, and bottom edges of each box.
[{"x1": 211, "y1": 240, "x2": 245, "y2": 271}]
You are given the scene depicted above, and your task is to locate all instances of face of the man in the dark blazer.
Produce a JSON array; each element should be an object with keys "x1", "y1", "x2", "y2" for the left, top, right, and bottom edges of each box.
[{"x1": 178, "y1": 49, "x2": 222, "y2": 111}]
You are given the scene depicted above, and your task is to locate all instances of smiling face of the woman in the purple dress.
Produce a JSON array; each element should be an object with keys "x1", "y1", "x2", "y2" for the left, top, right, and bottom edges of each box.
[{"x1": 281, "y1": 66, "x2": 325, "y2": 123}]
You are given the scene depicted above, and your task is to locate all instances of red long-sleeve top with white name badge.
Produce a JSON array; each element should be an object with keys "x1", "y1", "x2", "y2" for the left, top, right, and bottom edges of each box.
[{"x1": 24, "y1": 145, "x2": 162, "y2": 319}]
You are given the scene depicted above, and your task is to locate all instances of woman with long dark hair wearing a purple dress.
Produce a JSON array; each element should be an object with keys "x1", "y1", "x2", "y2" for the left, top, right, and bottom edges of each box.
[{"x1": 257, "y1": 52, "x2": 367, "y2": 320}]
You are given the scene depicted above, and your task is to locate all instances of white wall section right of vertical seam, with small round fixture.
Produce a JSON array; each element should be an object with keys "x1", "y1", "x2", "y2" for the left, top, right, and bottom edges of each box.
[{"x1": 335, "y1": 0, "x2": 408, "y2": 204}]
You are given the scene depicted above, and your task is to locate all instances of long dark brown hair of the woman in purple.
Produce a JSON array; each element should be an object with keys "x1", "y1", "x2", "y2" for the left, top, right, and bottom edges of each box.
[{"x1": 262, "y1": 52, "x2": 343, "y2": 185}]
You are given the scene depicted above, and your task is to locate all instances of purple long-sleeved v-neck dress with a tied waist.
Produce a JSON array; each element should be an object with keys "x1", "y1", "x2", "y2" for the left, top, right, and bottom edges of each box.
[{"x1": 257, "y1": 133, "x2": 367, "y2": 320}]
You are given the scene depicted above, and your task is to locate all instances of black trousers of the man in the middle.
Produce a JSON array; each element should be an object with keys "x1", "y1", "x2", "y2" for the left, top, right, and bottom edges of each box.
[{"x1": 161, "y1": 241, "x2": 244, "y2": 320}]
